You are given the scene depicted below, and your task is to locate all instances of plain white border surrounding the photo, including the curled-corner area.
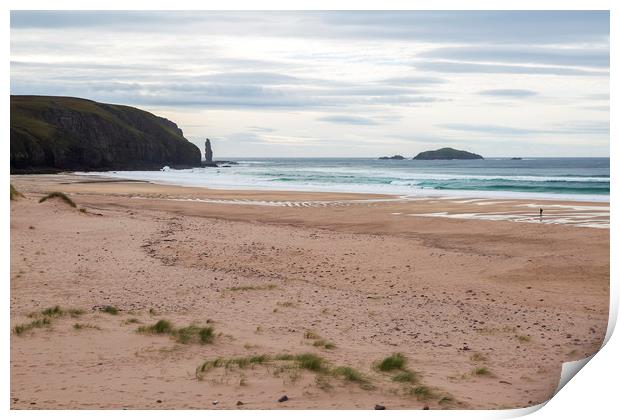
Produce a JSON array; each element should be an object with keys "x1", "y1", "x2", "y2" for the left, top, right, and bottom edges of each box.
[{"x1": 0, "y1": 0, "x2": 620, "y2": 420}]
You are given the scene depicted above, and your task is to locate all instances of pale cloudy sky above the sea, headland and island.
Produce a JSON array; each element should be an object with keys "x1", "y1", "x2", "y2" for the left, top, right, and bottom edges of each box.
[{"x1": 11, "y1": 11, "x2": 609, "y2": 157}]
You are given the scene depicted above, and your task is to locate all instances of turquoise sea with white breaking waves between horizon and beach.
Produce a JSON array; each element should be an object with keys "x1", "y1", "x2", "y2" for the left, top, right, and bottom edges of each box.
[{"x1": 80, "y1": 157, "x2": 610, "y2": 202}]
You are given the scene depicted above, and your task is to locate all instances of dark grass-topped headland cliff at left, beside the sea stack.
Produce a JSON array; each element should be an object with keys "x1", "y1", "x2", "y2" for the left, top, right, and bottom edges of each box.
[{"x1": 11, "y1": 96, "x2": 200, "y2": 173}]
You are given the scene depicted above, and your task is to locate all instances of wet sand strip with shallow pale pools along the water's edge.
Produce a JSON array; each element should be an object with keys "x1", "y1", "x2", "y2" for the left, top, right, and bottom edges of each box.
[{"x1": 12, "y1": 173, "x2": 610, "y2": 229}]
